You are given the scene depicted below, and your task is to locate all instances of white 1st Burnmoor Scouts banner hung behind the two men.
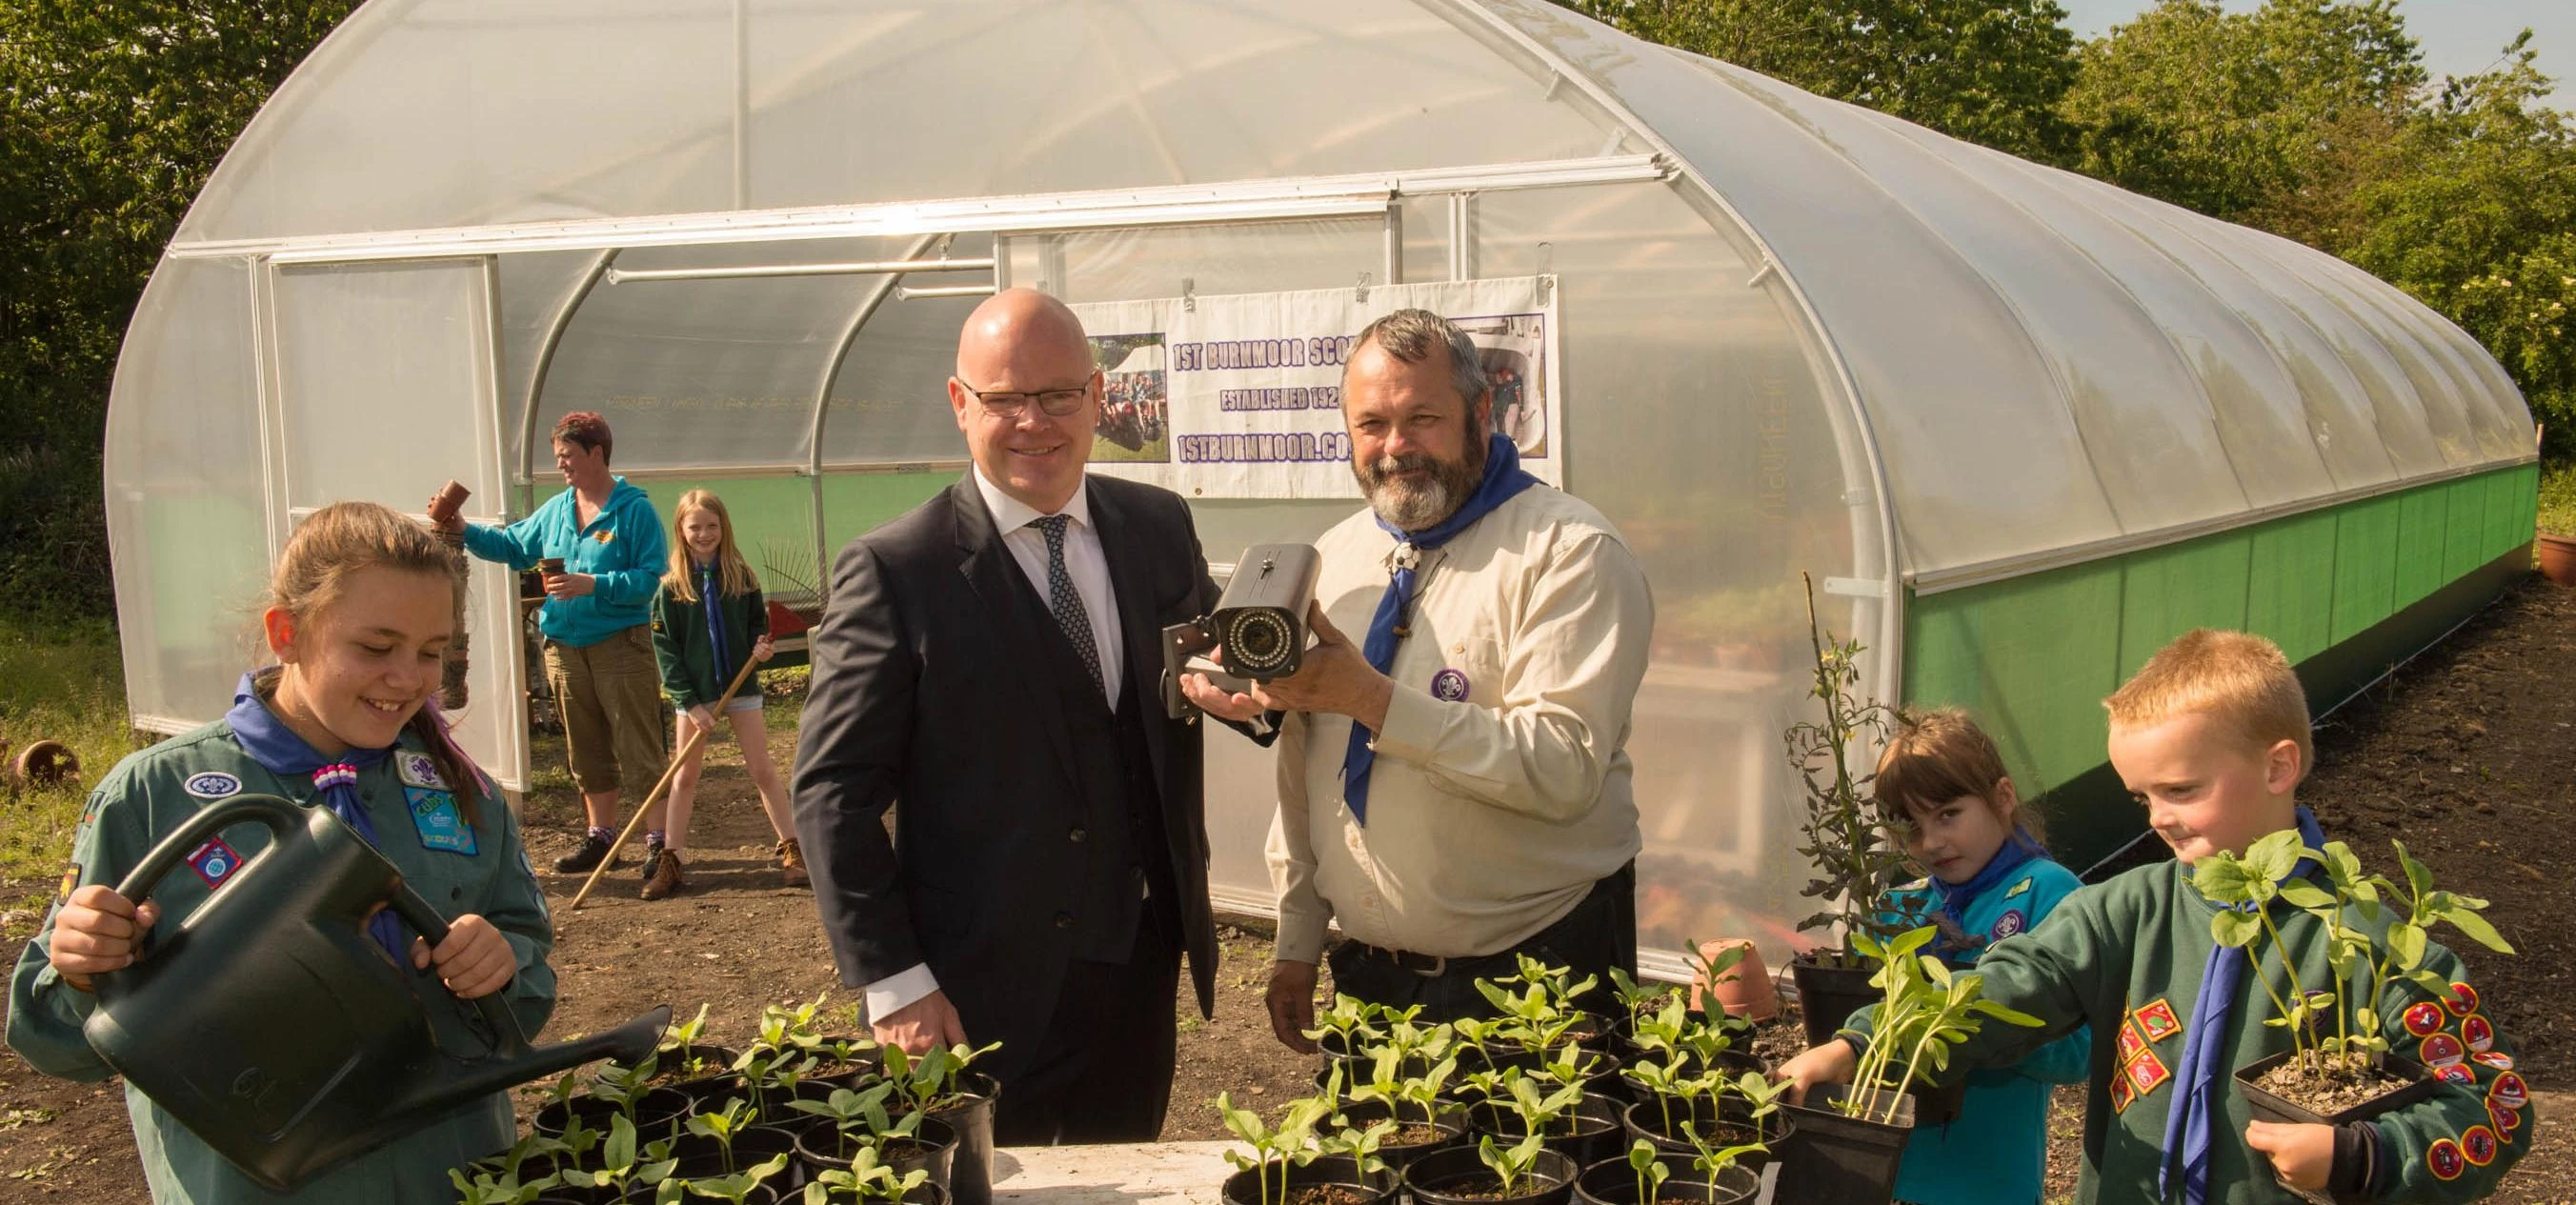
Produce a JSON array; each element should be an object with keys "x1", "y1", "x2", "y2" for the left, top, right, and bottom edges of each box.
[{"x1": 1075, "y1": 275, "x2": 1566, "y2": 497}]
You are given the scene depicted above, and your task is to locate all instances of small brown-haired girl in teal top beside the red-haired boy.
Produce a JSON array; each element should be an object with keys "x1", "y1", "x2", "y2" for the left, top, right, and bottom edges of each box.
[{"x1": 1876, "y1": 708, "x2": 2092, "y2": 1205}]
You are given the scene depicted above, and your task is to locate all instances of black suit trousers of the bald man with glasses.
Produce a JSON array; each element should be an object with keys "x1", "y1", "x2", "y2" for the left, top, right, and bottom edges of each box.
[{"x1": 992, "y1": 896, "x2": 1179, "y2": 1146}]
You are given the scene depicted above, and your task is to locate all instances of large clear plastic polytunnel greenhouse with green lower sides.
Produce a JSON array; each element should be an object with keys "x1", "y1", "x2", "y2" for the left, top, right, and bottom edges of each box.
[{"x1": 106, "y1": 0, "x2": 2537, "y2": 966}]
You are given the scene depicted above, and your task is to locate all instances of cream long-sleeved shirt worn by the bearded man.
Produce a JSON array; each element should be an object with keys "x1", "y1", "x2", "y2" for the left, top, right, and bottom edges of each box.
[{"x1": 1270, "y1": 484, "x2": 1654, "y2": 963}]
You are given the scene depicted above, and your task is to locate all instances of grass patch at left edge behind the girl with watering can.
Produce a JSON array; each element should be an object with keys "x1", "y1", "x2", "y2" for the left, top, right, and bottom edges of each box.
[{"x1": 0, "y1": 613, "x2": 136, "y2": 906}]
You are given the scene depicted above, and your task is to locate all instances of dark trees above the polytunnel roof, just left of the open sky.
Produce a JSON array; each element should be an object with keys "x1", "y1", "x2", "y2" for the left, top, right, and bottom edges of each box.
[{"x1": 1559, "y1": 0, "x2": 2076, "y2": 162}]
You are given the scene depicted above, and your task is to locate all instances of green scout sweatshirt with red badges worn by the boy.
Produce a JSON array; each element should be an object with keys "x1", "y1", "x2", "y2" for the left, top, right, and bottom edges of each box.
[{"x1": 1852, "y1": 863, "x2": 2535, "y2": 1205}]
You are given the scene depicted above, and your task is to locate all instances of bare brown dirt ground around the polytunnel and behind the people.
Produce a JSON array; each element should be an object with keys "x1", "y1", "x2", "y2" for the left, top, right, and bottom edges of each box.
[{"x1": 0, "y1": 582, "x2": 2576, "y2": 1205}]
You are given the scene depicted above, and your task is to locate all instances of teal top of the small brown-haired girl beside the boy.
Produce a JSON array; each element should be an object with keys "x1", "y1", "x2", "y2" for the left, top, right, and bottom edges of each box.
[{"x1": 1883, "y1": 857, "x2": 2092, "y2": 1205}]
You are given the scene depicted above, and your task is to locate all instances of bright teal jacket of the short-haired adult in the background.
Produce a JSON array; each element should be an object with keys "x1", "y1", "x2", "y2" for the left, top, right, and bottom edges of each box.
[{"x1": 466, "y1": 476, "x2": 670, "y2": 649}]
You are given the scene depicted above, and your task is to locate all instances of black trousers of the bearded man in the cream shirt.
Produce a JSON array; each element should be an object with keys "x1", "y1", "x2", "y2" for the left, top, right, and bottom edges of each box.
[{"x1": 1324, "y1": 863, "x2": 1636, "y2": 1025}]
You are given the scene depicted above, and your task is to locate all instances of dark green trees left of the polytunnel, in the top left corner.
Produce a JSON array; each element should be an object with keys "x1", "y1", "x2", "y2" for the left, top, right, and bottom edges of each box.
[{"x1": 0, "y1": 0, "x2": 352, "y2": 613}]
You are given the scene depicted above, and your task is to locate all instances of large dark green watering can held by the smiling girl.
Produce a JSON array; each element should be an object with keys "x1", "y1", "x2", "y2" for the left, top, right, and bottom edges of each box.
[{"x1": 85, "y1": 795, "x2": 670, "y2": 1192}]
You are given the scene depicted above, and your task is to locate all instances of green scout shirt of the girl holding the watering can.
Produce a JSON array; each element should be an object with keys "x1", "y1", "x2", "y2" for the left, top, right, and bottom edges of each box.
[{"x1": 8, "y1": 721, "x2": 553, "y2": 1205}]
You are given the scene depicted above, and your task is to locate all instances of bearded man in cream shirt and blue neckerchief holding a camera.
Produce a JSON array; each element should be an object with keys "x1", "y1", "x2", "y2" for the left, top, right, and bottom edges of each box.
[{"x1": 1182, "y1": 309, "x2": 1654, "y2": 1051}]
